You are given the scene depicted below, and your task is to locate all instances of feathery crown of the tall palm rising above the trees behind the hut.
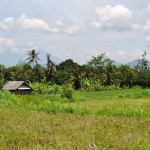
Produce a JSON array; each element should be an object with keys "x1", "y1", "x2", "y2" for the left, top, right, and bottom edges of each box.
[{"x1": 27, "y1": 49, "x2": 40, "y2": 68}]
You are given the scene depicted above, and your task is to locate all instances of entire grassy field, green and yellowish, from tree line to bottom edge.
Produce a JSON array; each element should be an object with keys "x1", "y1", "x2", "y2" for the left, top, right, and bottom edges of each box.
[{"x1": 0, "y1": 89, "x2": 150, "y2": 150}]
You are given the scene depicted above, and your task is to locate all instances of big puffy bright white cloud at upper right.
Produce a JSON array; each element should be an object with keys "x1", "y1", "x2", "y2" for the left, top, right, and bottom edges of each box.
[{"x1": 92, "y1": 5, "x2": 132, "y2": 31}]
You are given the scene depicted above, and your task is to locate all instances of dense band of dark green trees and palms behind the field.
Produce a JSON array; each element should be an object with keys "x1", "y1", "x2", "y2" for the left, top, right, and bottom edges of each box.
[{"x1": 0, "y1": 49, "x2": 150, "y2": 90}]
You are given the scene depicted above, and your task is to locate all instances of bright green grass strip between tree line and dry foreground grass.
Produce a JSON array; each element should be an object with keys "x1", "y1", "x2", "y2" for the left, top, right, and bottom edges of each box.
[{"x1": 0, "y1": 90, "x2": 150, "y2": 118}]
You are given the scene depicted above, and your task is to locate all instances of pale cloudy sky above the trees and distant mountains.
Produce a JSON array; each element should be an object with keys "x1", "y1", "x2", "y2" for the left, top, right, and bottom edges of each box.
[{"x1": 0, "y1": 0, "x2": 150, "y2": 64}]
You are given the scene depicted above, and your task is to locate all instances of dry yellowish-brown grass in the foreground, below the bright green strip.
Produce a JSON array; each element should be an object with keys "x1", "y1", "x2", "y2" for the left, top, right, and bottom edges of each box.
[{"x1": 0, "y1": 109, "x2": 150, "y2": 150}]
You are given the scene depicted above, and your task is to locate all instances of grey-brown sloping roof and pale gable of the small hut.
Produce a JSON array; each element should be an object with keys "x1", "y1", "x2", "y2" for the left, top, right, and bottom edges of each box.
[{"x1": 3, "y1": 81, "x2": 31, "y2": 91}]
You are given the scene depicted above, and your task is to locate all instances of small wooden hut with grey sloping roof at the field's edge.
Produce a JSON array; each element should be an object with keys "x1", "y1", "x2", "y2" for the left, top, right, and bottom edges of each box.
[{"x1": 3, "y1": 81, "x2": 33, "y2": 95}]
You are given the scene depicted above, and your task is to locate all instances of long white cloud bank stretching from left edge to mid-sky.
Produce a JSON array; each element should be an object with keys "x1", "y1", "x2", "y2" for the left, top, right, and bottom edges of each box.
[{"x1": 0, "y1": 14, "x2": 80, "y2": 35}]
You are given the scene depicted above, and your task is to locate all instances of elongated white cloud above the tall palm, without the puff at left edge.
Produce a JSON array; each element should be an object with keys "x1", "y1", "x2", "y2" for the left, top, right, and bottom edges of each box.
[{"x1": 17, "y1": 14, "x2": 80, "y2": 35}]
